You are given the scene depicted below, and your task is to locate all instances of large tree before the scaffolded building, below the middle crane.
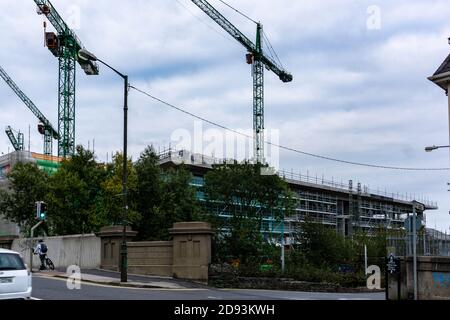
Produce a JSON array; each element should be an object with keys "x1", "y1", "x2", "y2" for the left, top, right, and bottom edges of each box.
[{"x1": 204, "y1": 163, "x2": 293, "y2": 262}]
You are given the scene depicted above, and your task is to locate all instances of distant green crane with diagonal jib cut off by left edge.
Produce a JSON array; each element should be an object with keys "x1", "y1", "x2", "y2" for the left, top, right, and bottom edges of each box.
[{"x1": 0, "y1": 66, "x2": 60, "y2": 156}]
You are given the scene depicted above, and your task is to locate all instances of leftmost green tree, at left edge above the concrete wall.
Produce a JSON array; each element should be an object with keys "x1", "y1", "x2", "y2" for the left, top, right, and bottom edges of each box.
[{"x1": 0, "y1": 163, "x2": 49, "y2": 234}]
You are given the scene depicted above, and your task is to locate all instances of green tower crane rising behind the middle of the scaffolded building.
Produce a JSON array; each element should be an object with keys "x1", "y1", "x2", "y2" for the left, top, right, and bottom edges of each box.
[{"x1": 191, "y1": 0, "x2": 293, "y2": 163}]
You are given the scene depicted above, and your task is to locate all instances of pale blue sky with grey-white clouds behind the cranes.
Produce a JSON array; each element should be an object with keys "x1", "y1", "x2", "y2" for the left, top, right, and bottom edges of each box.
[{"x1": 0, "y1": 0, "x2": 450, "y2": 232}]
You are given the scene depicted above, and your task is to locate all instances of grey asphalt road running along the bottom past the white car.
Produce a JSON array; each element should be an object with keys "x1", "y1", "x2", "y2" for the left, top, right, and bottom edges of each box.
[{"x1": 32, "y1": 275, "x2": 385, "y2": 300}]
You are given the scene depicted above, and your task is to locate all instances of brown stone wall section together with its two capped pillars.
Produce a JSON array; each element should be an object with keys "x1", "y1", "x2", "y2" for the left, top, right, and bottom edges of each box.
[{"x1": 99, "y1": 222, "x2": 212, "y2": 283}]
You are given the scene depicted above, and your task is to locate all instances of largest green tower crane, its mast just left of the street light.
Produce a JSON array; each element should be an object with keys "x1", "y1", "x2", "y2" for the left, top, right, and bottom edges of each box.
[{"x1": 34, "y1": 0, "x2": 99, "y2": 158}]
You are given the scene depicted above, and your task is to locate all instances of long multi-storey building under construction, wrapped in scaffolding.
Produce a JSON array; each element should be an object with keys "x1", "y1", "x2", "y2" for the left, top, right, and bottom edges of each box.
[{"x1": 156, "y1": 150, "x2": 438, "y2": 244}]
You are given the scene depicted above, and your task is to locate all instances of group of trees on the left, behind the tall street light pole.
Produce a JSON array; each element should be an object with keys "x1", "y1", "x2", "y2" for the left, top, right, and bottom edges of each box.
[{"x1": 0, "y1": 146, "x2": 199, "y2": 240}]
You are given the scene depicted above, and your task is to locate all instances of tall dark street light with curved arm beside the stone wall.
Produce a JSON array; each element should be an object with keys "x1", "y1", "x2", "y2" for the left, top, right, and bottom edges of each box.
[{"x1": 78, "y1": 49, "x2": 128, "y2": 282}]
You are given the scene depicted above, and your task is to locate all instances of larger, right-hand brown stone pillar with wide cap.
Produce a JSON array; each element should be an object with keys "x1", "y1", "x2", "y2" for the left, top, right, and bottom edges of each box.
[{"x1": 169, "y1": 222, "x2": 213, "y2": 283}]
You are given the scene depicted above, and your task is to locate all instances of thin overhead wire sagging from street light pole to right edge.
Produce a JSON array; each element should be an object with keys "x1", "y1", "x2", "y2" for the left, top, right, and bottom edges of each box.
[{"x1": 130, "y1": 85, "x2": 450, "y2": 171}]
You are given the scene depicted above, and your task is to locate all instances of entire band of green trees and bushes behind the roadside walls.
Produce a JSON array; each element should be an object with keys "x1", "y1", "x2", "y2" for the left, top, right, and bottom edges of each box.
[{"x1": 0, "y1": 146, "x2": 386, "y2": 286}]
